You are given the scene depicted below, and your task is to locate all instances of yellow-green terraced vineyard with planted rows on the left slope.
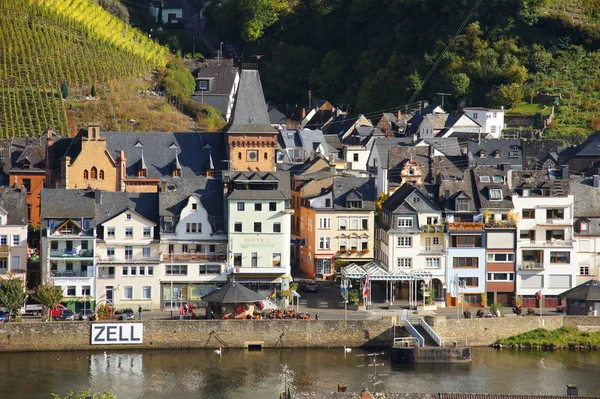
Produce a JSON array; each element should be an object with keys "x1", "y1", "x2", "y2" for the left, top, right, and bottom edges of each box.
[{"x1": 0, "y1": 0, "x2": 168, "y2": 138}]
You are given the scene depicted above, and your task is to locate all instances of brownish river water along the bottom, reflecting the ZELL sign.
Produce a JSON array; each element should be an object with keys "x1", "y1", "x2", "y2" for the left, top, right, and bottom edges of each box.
[{"x1": 8, "y1": 348, "x2": 600, "y2": 399}]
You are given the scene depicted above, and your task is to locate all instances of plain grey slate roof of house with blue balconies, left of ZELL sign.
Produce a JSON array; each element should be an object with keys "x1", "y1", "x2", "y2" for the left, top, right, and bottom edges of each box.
[{"x1": 40, "y1": 188, "x2": 96, "y2": 219}]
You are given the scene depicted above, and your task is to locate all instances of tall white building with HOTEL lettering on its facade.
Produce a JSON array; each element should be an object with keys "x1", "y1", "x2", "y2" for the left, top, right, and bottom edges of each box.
[{"x1": 223, "y1": 172, "x2": 293, "y2": 297}]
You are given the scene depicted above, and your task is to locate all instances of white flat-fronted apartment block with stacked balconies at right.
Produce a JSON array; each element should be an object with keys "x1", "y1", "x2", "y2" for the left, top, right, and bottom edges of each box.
[{"x1": 509, "y1": 170, "x2": 579, "y2": 308}]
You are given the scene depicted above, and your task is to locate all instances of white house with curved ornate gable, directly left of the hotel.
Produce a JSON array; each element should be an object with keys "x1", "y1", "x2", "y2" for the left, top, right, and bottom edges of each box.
[{"x1": 159, "y1": 177, "x2": 231, "y2": 309}]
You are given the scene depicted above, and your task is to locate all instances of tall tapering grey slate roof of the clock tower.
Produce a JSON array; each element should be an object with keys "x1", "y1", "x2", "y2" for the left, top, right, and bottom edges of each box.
[{"x1": 227, "y1": 69, "x2": 275, "y2": 133}]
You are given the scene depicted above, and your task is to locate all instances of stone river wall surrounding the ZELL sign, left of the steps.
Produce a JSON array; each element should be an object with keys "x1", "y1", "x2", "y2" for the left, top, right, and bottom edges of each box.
[{"x1": 0, "y1": 318, "x2": 393, "y2": 352}]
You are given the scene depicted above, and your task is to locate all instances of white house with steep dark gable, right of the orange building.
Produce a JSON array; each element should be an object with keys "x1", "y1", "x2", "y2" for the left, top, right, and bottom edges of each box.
[{"x1": 375, "y1": 185, "x2": 446, "y2": 302}]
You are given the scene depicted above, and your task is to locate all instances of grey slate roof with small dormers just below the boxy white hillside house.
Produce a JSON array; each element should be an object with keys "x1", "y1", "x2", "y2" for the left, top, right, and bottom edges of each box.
[{"x1": 467, "y1": 139, "x2": 523, "y2": 170}]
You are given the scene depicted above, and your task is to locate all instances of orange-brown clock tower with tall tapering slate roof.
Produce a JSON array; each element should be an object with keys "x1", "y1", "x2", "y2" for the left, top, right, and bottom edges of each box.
[{"x1": 226, "y1": 69, "x2": 279, "y2": 172}]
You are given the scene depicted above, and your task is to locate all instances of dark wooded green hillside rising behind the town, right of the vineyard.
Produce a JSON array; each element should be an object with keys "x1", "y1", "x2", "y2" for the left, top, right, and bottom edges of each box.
[{"x1": 209, "y1": 0, "x2": 600, "y2": 141}]
